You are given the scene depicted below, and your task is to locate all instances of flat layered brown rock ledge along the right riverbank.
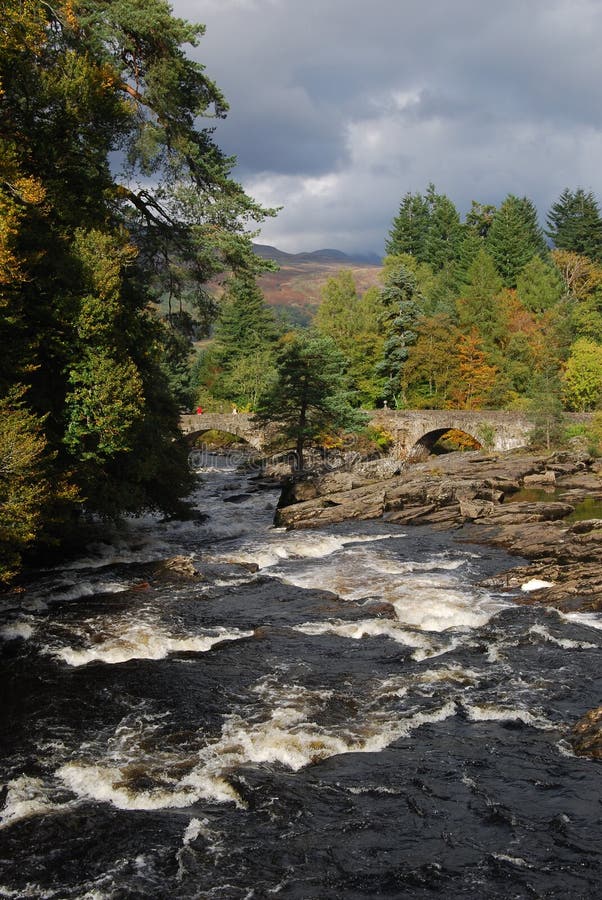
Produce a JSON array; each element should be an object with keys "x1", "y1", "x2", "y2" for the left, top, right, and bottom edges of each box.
[{"x1": 275, "y1": 451, "x2": 602, "y2": 612}]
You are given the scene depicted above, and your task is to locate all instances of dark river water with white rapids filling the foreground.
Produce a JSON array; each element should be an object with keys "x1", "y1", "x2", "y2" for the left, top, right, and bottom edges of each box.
[{"x1": 0, "y1": 459, "x2": 602, "y2": 900}]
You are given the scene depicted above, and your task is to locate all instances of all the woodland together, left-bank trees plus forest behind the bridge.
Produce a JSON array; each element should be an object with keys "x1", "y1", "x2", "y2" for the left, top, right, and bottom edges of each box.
[{"x1": 0, "y1": 0, "x2": 602, "y2": 582}]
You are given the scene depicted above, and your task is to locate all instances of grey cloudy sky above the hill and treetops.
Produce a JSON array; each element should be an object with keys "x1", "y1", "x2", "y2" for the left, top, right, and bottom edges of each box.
[{"x1": 172, "y1": 0, "x2": 602, "y2": 252}]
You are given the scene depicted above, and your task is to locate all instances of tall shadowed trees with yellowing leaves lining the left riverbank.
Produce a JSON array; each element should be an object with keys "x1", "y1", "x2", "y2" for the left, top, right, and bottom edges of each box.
[{"x1": 0, "y1": 0, "x2": 270, "y2": 581}]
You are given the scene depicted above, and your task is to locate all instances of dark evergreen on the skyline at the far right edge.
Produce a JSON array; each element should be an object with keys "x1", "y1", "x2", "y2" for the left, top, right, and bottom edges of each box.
[{"x1": 546, "y1": 188, "x2": 602, "y2": 262}]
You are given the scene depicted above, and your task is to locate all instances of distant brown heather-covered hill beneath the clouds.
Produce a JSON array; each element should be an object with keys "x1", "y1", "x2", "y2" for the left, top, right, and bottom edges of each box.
[{"x1": 253, "y1": 244, "x2": 382, "y2": 324}]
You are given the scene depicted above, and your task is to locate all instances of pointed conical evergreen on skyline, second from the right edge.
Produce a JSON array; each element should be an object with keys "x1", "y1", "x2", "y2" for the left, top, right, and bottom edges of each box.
[{"x1": 486, "y1": 194, "x2": 547, "y2": 287}]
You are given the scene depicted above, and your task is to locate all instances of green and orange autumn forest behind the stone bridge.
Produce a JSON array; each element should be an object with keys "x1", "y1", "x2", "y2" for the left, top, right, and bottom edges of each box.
[{"x1": 195, "y1": 185, "x2": 602, "y2": 411}]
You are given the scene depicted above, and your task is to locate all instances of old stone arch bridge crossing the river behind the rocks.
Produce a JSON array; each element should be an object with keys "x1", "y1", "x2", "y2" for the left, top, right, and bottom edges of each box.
[{"x1": 180, "y1": 409, "x2": 533, "y2": 459}]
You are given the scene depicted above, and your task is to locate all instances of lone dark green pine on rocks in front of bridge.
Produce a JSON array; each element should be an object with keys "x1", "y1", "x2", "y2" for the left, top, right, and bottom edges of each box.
[{"x1": 255, "y1": 332, "x2": 366, "y2": 470}]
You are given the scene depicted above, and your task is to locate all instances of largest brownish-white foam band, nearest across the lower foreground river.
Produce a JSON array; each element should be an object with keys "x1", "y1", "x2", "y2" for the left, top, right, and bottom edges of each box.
[{"x1": 55, "y1": 677, "x2": 456, "y2": 812}]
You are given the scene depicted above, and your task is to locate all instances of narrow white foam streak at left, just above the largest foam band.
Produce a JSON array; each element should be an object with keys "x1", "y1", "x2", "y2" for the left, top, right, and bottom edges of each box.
[{"x1": 50, "y1": 622, "x2": 253, "y2": 666}]
